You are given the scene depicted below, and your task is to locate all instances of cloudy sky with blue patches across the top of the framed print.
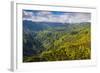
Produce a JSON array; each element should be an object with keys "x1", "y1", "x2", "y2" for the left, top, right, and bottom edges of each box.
[{"x1": 22, "y1": 10, "x2": 91, "y2": 23}]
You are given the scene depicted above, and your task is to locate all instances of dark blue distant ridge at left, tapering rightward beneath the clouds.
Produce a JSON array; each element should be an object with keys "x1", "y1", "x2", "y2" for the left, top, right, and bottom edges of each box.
[{"x1": 23, "y1": 20, "x2": 69, "y2": 31}]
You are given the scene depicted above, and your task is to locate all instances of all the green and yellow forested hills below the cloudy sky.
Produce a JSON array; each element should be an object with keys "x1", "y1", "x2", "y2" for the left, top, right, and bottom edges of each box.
[{"x1": 23, "y1": 20, "x2": 91, "y2": 62}]
